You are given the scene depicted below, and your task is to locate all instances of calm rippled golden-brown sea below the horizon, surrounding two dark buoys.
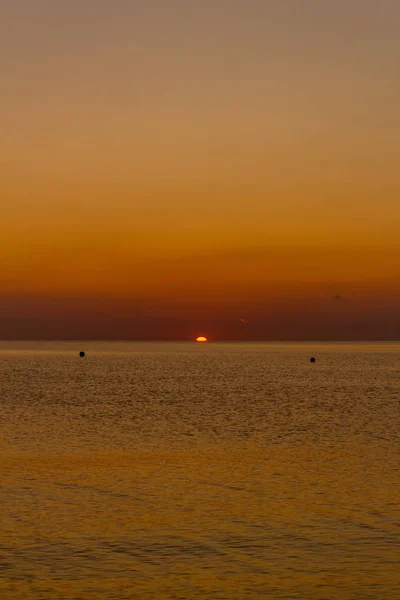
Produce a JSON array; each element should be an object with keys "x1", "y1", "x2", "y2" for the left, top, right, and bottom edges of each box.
[{"x1": 0, "y1": 342, "x2": 400, "y2": 600}]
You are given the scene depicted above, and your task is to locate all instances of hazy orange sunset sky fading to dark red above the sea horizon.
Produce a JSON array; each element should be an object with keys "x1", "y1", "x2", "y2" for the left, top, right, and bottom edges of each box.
[{"x1": 0, "y1": 0, "x2": 400, "y2": 340}]
